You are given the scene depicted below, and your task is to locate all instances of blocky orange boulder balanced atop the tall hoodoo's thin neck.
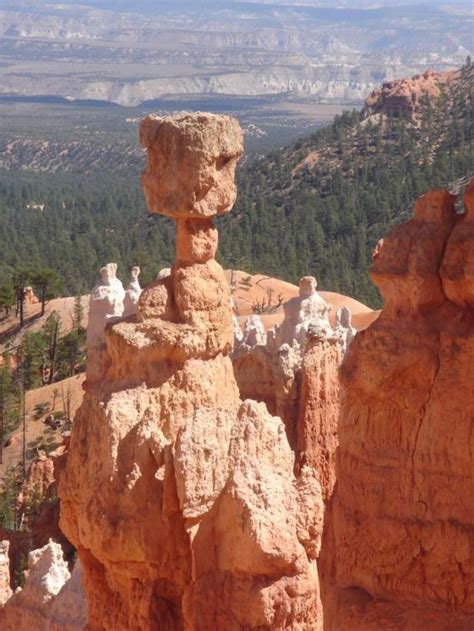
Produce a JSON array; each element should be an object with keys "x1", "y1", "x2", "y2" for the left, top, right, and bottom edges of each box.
[{"x1": 140, "y1": 113, "x2": 243, "y2": 219}]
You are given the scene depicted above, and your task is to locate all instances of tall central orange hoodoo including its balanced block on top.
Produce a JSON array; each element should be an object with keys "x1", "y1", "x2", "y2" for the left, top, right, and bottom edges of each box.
[{"x1": 60, "y1": 114, "x2": 323, "y2": 631}]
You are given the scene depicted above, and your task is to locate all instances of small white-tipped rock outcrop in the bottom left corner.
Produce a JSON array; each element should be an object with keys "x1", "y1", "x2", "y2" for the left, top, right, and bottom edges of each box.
[{"x1": 0, "y1": 541, "x2": 87, "y2": 631}]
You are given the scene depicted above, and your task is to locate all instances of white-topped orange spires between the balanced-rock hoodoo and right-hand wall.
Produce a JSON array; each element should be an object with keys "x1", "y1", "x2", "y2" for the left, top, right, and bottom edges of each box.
[{"x1": 232, "y1": 276, "x2": 348, "y2": 488}]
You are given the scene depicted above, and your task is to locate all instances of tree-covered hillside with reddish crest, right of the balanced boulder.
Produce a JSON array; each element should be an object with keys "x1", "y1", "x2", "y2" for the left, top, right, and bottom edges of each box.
[{"x1": 221, "y1": 60, "x2": 474, "y2": 306}]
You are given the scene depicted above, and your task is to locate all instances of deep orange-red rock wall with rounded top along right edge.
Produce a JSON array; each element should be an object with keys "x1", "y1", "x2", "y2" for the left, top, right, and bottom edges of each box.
[{"x1": 329, "y1": 184, "x2": 474, "y2": 629}]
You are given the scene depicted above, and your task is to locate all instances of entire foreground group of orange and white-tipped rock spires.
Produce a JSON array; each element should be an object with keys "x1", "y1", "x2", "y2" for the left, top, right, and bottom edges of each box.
[{"x1": 35, "y1": 114, "x2": 474, "y2": 631}]
